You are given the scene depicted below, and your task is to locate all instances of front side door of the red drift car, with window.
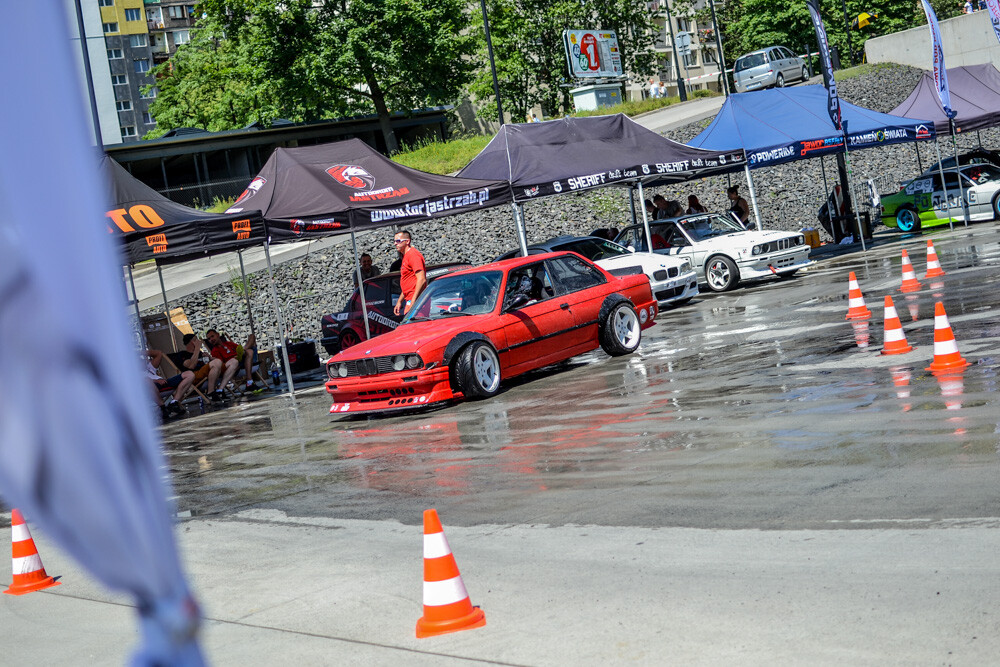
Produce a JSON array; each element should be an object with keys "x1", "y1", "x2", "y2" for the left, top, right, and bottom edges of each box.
[{"x1": 500, "y1": 262, "x2": 575, "y2": 376}]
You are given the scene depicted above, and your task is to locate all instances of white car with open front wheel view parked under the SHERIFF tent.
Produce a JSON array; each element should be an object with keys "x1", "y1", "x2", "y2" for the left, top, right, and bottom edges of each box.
[{"x1": 615, "y1": 213, "x2": 812, "y2": 292}]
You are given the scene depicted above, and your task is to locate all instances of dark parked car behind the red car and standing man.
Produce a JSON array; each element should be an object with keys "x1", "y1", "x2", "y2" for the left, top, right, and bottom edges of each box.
[{"x1": 320, "y1": 263, "x2": 471, "y2": 354}]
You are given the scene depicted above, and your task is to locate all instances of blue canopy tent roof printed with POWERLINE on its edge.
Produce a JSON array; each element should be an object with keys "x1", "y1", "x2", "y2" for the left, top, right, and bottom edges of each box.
[{"x1": 690, "y1": 85, "x2": 934, "y2": 167}]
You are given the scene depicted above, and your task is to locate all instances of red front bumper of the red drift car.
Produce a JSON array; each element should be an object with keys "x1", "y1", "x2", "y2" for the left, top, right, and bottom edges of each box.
[{"x1": 326, "y1": 366, "x2": 455, "y2": 414}]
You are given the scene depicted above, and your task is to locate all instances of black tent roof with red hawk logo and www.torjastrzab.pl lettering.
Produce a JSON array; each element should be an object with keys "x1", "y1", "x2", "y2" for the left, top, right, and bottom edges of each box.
[{"x1": 227, "y1": 139, "x2": 511, "y2": 243}]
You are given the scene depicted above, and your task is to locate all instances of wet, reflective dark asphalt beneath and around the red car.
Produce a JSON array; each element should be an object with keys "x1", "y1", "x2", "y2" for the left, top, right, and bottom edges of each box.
[{"x1": 163, "y1": 223, "x2": 1000, "y2": 530}]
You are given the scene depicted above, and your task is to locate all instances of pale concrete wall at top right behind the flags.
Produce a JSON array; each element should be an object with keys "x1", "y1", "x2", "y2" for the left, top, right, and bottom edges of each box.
[{"x1": 865, "y1": 10, "x2": 1000, "y2": 70}]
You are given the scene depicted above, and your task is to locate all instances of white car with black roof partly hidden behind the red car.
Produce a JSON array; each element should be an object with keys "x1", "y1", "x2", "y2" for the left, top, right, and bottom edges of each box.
[{"x1": 497, "y1": 236, "x2": 698, "y2": 308}]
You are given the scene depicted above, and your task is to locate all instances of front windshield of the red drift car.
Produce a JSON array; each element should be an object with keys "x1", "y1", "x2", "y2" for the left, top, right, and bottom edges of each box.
[{"x1": 403, "y1": 271, "x2": 503, "y2": 324}]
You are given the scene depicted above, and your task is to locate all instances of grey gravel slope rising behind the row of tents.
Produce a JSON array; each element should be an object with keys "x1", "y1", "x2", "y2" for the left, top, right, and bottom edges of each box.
[{"x1": 162, "y1": 66, "x2": 998, "y2": 350}]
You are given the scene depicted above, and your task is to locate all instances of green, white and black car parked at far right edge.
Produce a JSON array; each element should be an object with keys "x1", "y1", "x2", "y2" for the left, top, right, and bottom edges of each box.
[{"x1": 880, "y1": 163, "x2": 1000, "y2": 232}]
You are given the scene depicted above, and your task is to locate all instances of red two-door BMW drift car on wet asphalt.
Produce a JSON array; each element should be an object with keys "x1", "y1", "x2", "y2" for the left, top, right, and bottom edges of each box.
[{"x1": 326, "y1": 252, "x2": 657, "y2": 414}]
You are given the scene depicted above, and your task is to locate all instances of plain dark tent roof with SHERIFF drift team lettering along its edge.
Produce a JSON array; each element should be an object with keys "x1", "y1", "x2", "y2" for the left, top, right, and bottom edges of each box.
[{"x1": 458, "y1": 114, "x2": 746, "y2": 201}]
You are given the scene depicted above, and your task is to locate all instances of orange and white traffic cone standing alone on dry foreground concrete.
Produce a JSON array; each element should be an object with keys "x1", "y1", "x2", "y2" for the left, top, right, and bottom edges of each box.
[{"x1": 417, "y1": 510, "x2": 486, "y2": 639}]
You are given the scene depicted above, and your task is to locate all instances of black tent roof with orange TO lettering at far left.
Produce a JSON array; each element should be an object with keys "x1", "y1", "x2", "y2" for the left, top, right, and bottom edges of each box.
[{"x1": 100, "y1": 155, "x2": 266, "y2": 264}]
